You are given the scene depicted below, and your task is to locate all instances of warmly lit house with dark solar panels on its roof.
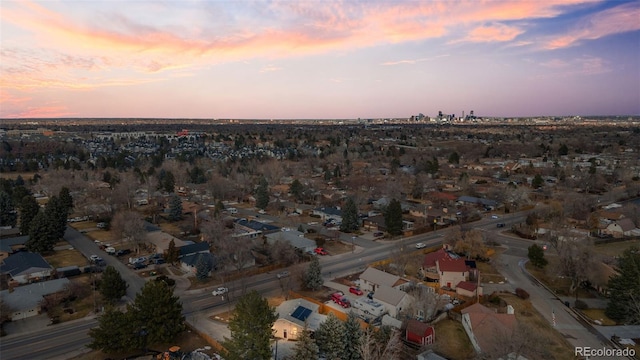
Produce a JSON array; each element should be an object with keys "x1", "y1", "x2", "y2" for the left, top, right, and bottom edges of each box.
[{"x1": 272, "y1": 299, "x2": 327, "y2": 340}]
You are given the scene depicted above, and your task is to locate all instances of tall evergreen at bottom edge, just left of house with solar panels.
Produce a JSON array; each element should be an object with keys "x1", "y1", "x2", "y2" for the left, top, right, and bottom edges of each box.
[{"x1": 223, "y1": 290, "x2": 278, "y2": 360}]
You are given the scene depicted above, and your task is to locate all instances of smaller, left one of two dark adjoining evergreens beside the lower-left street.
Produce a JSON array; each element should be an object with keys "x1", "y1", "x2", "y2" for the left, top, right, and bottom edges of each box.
[{"x1": 88, "y1": 306, "x2": 136, "y2": 354}]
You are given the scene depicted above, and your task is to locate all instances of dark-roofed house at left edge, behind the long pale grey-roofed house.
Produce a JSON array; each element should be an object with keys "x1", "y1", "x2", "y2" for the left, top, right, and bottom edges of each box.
[{"x1": 0, "y1": 251, "x2": 53, "y2": 284}]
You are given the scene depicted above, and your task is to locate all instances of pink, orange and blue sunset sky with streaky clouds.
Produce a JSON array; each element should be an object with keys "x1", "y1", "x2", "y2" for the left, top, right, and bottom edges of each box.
[{"x1": 0, "y1": 0, "x2": 640, "y2": 119}]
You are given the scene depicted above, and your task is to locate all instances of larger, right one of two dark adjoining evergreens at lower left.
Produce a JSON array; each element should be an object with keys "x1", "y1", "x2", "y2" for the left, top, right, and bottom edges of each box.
[{"x1": 127, "y1": 281, "x2": 186, "y2": 348}]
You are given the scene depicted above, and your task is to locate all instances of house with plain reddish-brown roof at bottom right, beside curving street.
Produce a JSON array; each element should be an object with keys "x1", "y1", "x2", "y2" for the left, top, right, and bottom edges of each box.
[{"x1": 462, "y1": 303, "x2": 516, "y2": 353}]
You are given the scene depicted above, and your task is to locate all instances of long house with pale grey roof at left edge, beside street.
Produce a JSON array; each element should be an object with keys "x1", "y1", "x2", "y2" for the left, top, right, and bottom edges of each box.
[{"x1": 0, "y1": 278, "x2": 71, "y2": 321}]
